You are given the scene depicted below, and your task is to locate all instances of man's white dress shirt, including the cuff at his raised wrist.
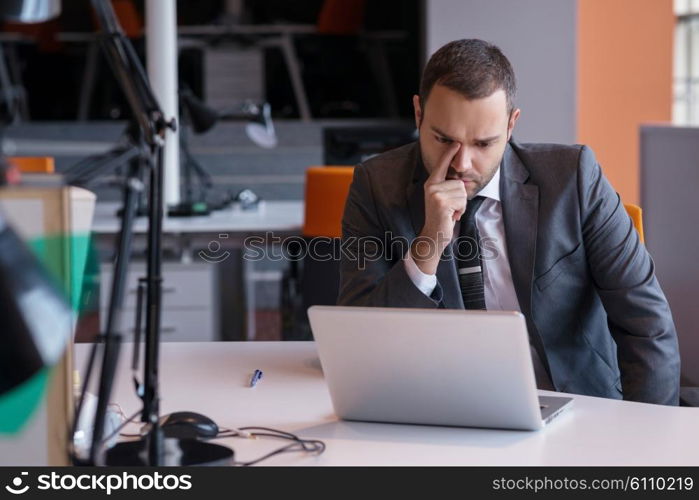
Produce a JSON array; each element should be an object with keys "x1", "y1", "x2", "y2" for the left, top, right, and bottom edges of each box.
[{"x1": 404, "y1": 167, "x2": 520, "y2": 311}]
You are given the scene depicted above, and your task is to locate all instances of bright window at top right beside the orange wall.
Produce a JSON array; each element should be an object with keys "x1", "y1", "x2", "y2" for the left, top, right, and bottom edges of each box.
[{"x1": 672, "y1": 0, "x2": 699, "y2": 125}]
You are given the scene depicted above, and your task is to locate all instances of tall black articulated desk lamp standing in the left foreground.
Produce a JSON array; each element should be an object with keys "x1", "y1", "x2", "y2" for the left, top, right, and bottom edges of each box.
[{"x1": 71, "y1": 0, "x2": 233, "y2": 466}]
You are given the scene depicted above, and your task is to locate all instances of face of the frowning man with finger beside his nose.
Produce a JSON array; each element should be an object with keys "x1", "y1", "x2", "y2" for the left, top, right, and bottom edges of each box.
[{"x1": 413, "y1": 85, "x2": 520, "y2": 199}]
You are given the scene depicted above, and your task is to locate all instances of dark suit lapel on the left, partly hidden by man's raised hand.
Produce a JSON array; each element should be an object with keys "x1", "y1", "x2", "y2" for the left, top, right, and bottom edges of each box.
[{"x1": 406, "y1": 143, "x2": 464, "y2": 309}]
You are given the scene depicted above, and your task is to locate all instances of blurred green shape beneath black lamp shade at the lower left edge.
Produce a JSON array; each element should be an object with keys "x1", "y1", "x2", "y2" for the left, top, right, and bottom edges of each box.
[{"x1": 0, "y1": 367, "x2": 51, "y2": 434}]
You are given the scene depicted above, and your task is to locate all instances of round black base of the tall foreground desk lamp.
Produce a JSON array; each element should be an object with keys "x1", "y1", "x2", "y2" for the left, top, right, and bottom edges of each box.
[{"x1": 106, "y1": 438, "x2": 234, "y2": 467}]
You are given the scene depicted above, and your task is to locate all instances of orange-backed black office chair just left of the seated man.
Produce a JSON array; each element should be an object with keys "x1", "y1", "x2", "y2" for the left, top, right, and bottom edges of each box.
[{"x1": 281, "y1": 166, "x2": 354, "y2": 340}]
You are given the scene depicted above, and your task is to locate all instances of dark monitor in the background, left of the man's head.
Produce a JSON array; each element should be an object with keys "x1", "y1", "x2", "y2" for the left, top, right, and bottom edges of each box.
[{"x1": 323, "y1": 123, "x2": 418, "y2": 165}]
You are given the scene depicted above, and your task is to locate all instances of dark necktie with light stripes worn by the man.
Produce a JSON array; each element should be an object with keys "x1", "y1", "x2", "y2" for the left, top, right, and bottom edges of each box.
[{"x1": 455, "y1": 196, "x2": 485, "y2": 309}]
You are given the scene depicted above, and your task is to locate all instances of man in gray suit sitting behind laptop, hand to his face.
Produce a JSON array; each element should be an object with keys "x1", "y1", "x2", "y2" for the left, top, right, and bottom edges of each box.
[{"x1": 338, "y1": 40, "x2": 680, "y2": 405}]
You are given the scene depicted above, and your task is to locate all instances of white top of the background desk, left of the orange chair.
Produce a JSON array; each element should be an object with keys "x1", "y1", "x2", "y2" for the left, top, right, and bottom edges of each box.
[{"x1": 92, "y1": 201, "x2": 304, "y2": 234}]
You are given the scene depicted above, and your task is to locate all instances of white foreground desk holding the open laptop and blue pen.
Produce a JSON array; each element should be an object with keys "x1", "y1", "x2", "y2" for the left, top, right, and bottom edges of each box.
[{"x1": 76, "y1": 342, "x2": 699, "y2": 466}]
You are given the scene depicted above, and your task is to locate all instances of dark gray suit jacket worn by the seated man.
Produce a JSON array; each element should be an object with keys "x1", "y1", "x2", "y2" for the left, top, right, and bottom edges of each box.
[{"x1": 338, "y1": 141, "x2": 680, "y2": 405}]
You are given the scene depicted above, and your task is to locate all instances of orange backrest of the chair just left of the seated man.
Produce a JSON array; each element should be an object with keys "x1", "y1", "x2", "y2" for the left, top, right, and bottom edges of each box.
[{"x1": 303, "y1": 166, "x2": 354, "y2": 238}]
